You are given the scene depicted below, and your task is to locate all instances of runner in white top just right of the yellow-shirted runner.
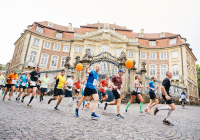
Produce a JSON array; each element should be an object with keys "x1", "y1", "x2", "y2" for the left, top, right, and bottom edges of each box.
[{"x1": 65, "y1": 76, "x2": 74, "y2": 106}]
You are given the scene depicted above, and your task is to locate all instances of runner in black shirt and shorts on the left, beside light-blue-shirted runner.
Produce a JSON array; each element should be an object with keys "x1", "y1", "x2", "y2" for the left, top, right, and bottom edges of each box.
[{"x1": 21, "y1": 67, "x2": 40, "y2": 107}]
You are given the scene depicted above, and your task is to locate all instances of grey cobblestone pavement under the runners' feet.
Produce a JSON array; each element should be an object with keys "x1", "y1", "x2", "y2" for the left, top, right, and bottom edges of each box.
[{"x1": 0, "y1": 94, "x2": 200, "y2": 140}]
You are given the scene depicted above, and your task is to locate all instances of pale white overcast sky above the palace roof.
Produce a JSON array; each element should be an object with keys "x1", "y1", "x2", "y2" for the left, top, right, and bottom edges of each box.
[{"x1": 0, "y1": 0, "x2": 200, "y2": 64}]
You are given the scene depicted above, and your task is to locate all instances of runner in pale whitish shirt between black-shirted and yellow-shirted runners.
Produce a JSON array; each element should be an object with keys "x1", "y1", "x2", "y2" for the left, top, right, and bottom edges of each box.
[{"x1": 40, "y1": 73, "x2": 49, "y2": 102}]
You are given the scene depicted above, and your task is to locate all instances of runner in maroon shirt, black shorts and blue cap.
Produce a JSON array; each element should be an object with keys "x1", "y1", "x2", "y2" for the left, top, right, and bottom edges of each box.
[{"x1": 104, "y1": 70, "x2": 125, "y2": 119}]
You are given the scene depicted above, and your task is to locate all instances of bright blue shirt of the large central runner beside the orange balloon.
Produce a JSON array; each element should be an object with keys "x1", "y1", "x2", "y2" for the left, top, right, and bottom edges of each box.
[{"x1": 86, "y1": 70, "x2": 99, "y2": 89}]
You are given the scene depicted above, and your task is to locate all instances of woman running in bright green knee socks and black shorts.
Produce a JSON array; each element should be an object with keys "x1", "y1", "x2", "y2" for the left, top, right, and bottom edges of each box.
[{"x1": 125, "y1": 75, "x2": 144, "y2": 115}]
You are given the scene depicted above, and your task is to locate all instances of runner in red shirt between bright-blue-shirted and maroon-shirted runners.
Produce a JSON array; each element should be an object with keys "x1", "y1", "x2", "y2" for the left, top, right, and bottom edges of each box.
[{"x1": 98, "y1": 75, "x2": 110, "y2": 108}]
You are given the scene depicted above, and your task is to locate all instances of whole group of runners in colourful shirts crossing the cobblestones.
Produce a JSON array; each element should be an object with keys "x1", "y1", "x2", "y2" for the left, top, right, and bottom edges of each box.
[{"x1": 0, "y1": 65, "x2": 175, "y2": 125}]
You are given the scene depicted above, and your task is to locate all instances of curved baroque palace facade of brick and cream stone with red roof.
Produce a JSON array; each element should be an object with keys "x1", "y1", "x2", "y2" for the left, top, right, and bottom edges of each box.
[{"x1": 10, "y1": 21, "x2": 198, "y2": 101}]
